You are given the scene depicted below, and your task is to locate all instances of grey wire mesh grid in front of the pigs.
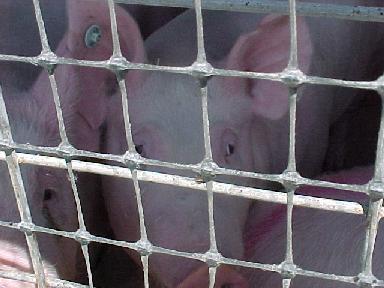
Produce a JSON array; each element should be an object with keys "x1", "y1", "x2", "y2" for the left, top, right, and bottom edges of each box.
[{"x1": 0, "y1": 0, "x2": 384, "y2": 288}]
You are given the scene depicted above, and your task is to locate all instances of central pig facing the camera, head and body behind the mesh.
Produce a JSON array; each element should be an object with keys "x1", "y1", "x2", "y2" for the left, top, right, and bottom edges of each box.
[{"x1": 46, "y1": 1, "x2": 381, "y2": 287}]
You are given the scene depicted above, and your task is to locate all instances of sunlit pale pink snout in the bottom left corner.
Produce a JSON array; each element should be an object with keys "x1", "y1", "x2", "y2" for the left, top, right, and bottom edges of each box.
[{"x1": 0, "y1": 243, "x2": 59, "y2": 288}]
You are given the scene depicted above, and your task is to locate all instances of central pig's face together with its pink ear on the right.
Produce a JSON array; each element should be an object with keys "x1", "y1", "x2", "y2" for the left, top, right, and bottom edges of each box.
[{"x1": 104, "y1": 16, "x2": 311, "y2": 287}]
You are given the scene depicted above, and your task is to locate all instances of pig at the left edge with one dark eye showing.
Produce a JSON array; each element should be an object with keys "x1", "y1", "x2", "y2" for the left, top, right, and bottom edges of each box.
[{"x1": 0, "y1": 95, "x2": 82, "y2": 288}]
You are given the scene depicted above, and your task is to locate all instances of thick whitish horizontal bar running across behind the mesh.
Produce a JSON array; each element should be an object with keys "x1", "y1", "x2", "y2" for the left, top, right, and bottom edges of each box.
[{"x1": 0, "y1": 152, "x2": 384, "y2": 217}]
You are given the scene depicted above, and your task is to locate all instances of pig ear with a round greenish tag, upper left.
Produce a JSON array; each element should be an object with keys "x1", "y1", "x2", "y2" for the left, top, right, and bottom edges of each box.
[{"x1": 62, "y1": 0, "x2": 145, "y2": 129}]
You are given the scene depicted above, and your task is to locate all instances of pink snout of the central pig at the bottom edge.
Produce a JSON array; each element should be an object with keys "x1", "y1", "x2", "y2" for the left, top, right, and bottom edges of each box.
[{"x1": 177, "y1": 266, "x2": 249, "y2": 288}]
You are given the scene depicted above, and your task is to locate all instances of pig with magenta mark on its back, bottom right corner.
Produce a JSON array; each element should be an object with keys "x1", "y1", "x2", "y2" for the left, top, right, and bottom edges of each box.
[{"x1": 248, "y1": 166, "x2": 384, "y2": 288}]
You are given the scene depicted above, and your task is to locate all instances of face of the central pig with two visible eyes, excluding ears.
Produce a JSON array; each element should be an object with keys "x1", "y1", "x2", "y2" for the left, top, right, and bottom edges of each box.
[{"x1": 103, "y1": 73, "x2": 255, "y2": 287}]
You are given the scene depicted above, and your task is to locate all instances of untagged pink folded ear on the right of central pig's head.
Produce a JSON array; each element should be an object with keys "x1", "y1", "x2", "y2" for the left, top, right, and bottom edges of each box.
[{"x1": 227, "y1": 15, "x2": 312, "y2": 119}]
